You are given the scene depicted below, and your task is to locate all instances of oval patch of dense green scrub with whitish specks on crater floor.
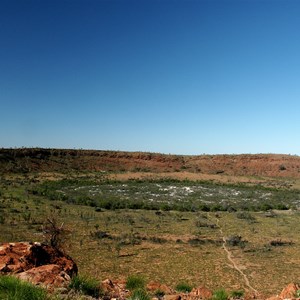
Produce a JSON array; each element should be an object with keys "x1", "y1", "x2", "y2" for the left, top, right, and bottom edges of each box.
[{"x1": 28, "y1": 178, "x2": 300, "y2": 213}]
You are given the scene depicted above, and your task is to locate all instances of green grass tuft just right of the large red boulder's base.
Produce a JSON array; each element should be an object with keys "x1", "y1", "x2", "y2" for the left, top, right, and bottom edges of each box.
[{"x1": 69, "y1": 276, "x2": 102, "y2": 298}]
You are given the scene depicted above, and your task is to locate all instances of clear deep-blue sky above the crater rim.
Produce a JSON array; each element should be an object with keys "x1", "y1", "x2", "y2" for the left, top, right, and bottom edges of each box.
[{"x1": 0, "y1": 0, "x2": 300, "y2": 155}]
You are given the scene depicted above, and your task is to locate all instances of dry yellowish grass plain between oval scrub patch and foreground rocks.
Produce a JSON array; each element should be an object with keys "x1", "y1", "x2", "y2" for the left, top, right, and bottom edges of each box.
[{"x1": 0, "y1": 174, "x2": 300, "y2": 295}]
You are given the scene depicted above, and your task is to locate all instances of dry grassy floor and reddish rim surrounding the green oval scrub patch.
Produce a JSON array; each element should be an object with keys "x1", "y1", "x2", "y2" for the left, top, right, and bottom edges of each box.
[{"x1": 0, "y1": 149, "x2": 300, "y2": 295}]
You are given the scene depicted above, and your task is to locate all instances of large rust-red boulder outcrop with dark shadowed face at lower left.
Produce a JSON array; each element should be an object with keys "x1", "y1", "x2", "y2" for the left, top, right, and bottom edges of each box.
[{"x1": 0, "y1": 243, "x2": 78, "y2": 288}]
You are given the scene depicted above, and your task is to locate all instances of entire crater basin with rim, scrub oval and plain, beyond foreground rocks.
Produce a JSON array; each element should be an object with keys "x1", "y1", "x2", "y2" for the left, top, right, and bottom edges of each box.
[{"x1": 0, "y1": 148, "x2": 300, "y2": 300}]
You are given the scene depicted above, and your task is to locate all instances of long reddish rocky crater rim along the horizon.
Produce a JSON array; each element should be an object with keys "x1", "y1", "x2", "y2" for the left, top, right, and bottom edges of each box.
[{"x1": 0, "y1": 148, "x2": 300, "y2": 178}]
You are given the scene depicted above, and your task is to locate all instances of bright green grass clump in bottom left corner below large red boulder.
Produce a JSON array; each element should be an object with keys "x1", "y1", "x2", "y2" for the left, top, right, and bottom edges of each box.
[{"x1": 0, "y1": 276, "x2": 47, "y2": 300}]
